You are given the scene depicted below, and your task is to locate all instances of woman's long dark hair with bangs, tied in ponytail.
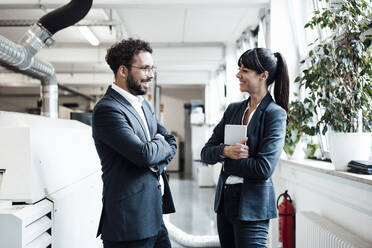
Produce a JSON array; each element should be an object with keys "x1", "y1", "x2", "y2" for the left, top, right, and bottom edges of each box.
[{"x1": 238, "y1": 48, "x2": 289, "y2": 113}]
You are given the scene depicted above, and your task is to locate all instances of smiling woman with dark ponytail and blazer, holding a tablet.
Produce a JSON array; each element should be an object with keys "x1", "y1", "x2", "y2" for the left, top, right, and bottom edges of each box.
[{"x1": 201, "y1": 48, "x2": 289, "y2": 248}]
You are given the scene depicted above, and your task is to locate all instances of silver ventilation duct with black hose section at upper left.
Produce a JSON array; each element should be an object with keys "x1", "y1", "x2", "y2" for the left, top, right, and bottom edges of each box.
[{"x1": 0, "y1": 0, "x2": 92, "y2": 118}]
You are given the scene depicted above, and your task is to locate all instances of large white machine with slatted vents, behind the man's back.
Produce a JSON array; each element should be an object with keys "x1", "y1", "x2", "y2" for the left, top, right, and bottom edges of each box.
[{"x1": 0, "y1": 111, "x2": 102, "y2": 248}]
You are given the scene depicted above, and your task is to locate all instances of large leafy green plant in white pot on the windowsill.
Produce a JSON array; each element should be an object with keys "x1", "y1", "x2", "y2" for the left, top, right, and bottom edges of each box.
[{"x1": 295, "y1": 0, "x2": 372, "y2": 170}]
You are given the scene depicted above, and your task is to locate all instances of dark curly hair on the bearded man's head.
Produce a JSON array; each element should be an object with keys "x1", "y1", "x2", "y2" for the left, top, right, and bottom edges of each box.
[{"x1": 105, "y1": 38, "x2": 152, "y2": 75}]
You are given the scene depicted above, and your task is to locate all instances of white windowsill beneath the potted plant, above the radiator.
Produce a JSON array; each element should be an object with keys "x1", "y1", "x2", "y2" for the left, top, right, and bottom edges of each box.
[{"x1": 280, "y1": 159, "x2": 372, "y2": 185}]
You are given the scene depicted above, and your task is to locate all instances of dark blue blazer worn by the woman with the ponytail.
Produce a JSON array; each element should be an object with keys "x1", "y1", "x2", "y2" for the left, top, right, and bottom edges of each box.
[{"x1": 201, "y1": 93, "x2": 287, "y2": 221}]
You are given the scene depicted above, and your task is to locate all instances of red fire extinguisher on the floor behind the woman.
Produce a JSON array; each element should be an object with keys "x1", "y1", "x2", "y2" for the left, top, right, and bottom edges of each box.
[{"x1": 276, "y1": 190, "x2": 295, "y2": 248}]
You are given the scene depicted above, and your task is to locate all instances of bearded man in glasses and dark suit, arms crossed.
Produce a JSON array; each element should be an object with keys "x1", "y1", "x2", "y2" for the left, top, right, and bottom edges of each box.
[{"x1": 92, "y1": 39, "x2": 177, "y2": 248}]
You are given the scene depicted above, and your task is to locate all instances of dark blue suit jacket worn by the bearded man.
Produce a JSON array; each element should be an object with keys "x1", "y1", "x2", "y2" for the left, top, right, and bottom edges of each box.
[{"x1": 92, "y1": 87, "x2": 177, "y2": 241}]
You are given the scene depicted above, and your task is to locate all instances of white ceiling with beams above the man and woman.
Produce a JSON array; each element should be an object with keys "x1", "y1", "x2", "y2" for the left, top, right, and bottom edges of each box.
[{"x1": 0, "y1": 0, "x2": 269, "y2": 90}]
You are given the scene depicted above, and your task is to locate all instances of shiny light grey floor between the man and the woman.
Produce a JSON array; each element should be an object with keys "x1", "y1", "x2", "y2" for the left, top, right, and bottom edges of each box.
[{"x1": 169, "y1": 173, "x2": 217, "y2": 248}]
